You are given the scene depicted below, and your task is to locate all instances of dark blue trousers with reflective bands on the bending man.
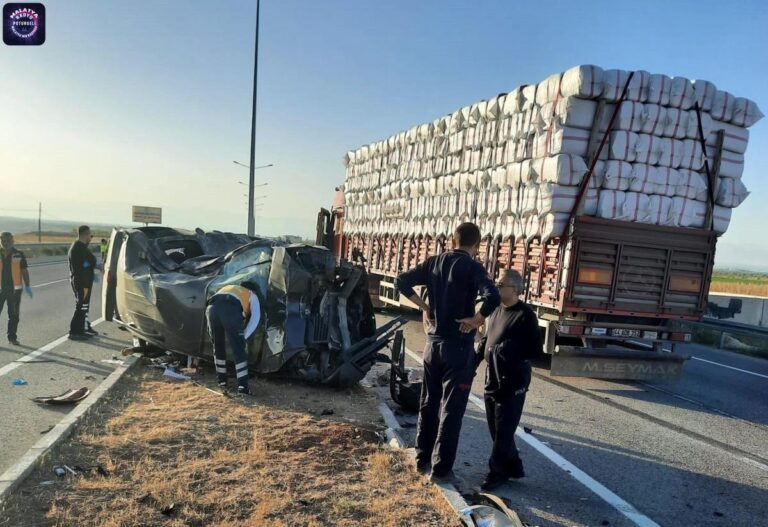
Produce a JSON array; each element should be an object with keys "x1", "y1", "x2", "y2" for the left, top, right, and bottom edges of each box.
[{"x1": 205, "y1": 295, "x2": 248, "y2": 387}]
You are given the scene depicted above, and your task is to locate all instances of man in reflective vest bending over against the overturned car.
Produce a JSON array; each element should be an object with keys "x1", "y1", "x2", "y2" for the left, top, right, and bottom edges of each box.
[{"x1": 205, "y1": 282, "x2": 261, "y2": 395}]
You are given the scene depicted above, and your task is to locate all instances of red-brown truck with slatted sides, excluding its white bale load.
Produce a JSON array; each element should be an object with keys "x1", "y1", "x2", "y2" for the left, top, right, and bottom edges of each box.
[{"x1": 316, "y1": 93, "x2": 723, "y2": 380}]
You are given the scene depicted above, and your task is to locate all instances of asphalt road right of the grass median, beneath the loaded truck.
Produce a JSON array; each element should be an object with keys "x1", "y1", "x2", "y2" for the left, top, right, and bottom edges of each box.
[{"x1": 382, "y1": 316, "x2": 768, "y2": 527}]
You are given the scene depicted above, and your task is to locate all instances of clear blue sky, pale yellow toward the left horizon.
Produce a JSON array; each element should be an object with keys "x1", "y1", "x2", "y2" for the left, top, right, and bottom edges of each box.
[{"x1": 0, "y1": 0, "x2": 768, "y2": 269}]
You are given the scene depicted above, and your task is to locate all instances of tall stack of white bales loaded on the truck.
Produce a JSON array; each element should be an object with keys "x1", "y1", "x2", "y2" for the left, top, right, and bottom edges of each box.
[{"x1": 344, "y1": 66, "x2": 763, "y2": 241}]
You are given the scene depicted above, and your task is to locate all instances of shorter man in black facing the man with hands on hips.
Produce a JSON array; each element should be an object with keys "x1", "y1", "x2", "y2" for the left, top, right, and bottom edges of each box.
[{"x1": 475, "y1": 269, "x2": 542, "y2": 490}]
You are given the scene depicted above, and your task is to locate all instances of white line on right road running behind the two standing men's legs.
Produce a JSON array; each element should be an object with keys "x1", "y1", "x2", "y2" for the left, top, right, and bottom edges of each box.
[{"x1": 405, "y1": 348, "x2": 660, "y2": 527}]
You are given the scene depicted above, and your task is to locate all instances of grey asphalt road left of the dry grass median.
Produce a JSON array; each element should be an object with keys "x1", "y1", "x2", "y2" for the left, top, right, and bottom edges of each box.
[{"x1": 0, "y1": 257, "x2": 129, "y2": 473}]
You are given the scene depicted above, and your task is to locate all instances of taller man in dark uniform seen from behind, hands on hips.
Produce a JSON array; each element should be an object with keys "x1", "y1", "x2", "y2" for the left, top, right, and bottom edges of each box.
[{"x1": 396, "y1": 223, "x2": 499, "y2": 481}]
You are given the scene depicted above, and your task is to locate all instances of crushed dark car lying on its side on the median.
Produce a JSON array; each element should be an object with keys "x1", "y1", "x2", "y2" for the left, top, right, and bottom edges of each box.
[{"x1": 104, "y1": 227, "x2": 402, "y2": 386}]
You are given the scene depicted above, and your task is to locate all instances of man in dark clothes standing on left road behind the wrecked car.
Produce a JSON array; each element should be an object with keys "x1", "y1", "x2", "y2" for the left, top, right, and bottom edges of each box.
[{"x1": 68, "y1": 225, "x2": 97, "y2": 340}]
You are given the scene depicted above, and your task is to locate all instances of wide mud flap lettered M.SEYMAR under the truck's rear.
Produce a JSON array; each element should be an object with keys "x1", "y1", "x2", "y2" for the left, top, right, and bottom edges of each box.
[{"x1": 550, "y1": 346, "x2": 690, "y2": 381}]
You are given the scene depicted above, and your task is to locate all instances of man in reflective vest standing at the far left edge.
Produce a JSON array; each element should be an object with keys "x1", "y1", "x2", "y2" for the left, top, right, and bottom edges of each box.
[{"x1": 0, "y1": 232, "x2": 32, "y2": 346}]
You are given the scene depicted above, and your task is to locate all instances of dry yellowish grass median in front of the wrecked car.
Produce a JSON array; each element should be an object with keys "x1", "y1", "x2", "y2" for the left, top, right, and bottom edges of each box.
[{"x1": 0, "y1": 366, "x2": 460, "y2": 527}]
